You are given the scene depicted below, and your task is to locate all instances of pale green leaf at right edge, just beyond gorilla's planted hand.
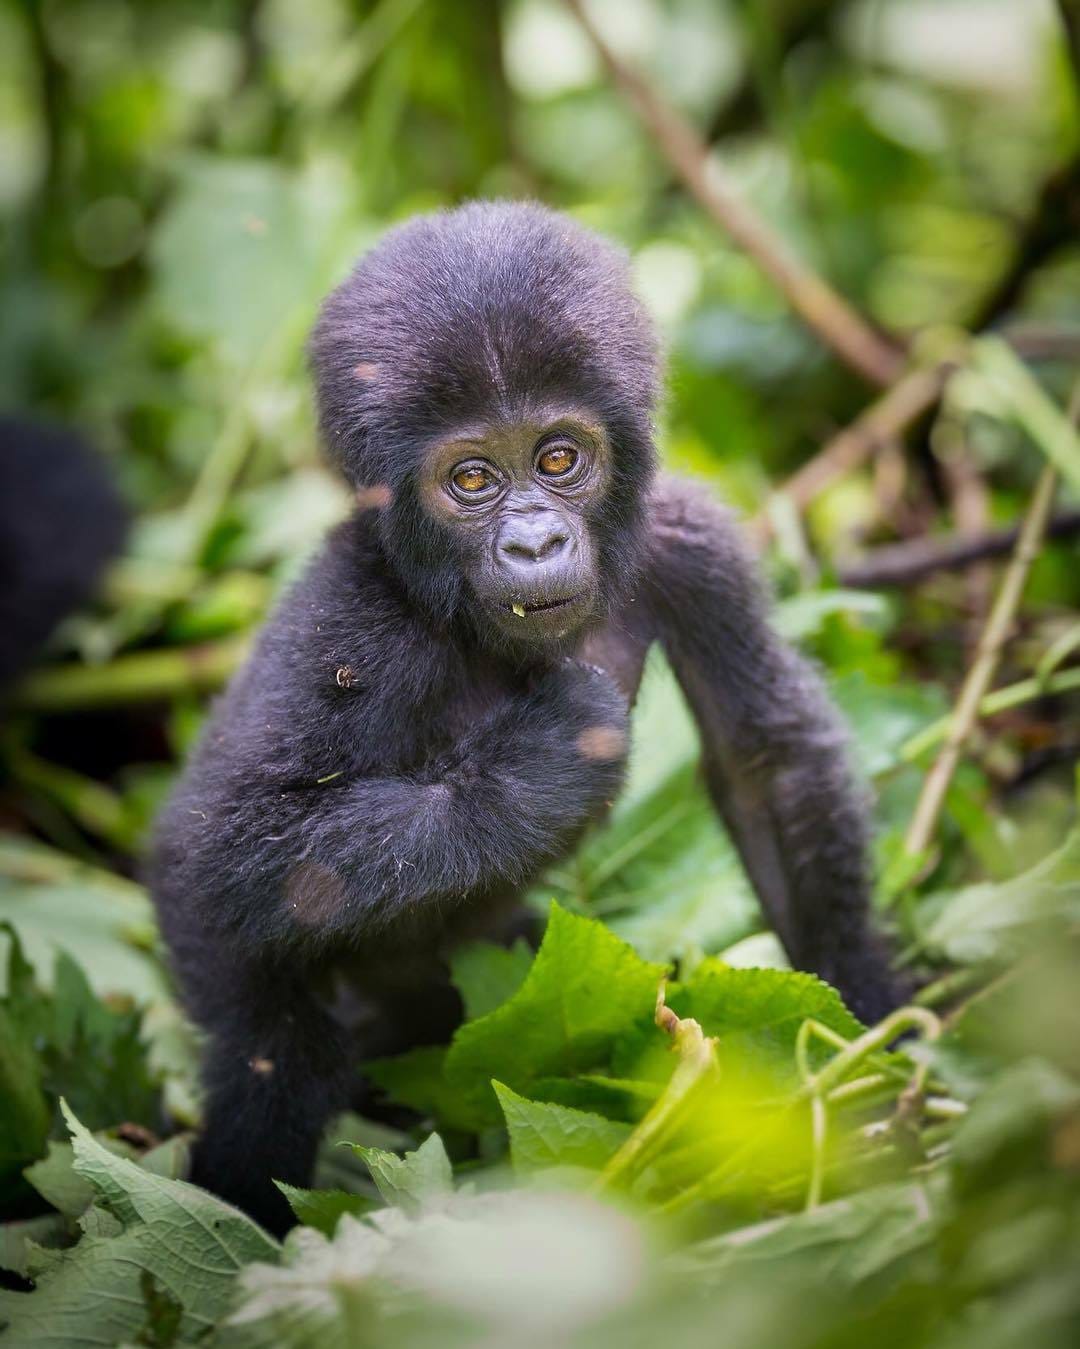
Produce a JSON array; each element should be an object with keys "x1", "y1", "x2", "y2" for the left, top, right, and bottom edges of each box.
[{"x1": 924, "y1": 828, "x2": 1080, "y2": 963}]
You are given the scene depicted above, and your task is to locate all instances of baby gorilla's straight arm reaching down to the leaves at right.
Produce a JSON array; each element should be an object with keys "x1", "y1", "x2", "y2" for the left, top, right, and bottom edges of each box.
[{"x1": 647, "y1": 482, "x2": 898, "y2": 1021}]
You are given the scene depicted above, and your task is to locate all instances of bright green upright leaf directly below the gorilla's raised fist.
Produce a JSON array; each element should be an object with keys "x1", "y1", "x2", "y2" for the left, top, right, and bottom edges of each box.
[{"x1": 445, "y1": 904, "x2": 665, "y2": 1122}]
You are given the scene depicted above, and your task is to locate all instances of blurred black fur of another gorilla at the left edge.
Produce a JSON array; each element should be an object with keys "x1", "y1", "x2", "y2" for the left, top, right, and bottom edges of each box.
[{"x1": 0, "y1": 417, "x2": 125, "y2": 689}]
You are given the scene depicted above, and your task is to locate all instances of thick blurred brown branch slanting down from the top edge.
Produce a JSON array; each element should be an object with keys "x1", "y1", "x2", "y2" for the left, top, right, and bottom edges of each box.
[{"x1": 566, "y1": 0, "x2": 903, "y2": 384}]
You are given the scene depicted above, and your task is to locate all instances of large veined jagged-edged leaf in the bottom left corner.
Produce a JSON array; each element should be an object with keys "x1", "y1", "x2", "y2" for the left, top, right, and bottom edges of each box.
[{"x1": 0, "y1": 1112, "x2": 279, "y2": 1349}]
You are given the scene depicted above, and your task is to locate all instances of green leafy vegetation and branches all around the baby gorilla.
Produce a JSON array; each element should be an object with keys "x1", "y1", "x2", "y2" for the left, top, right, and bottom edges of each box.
[{"x1": 0, "y1": 0, "x2": 1080, "y2": 1349}]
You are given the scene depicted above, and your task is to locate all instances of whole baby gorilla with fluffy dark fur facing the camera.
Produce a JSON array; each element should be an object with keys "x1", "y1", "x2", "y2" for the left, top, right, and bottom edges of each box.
[{"x1": 152, "y1": 204, "x2": 894, "y2": 1230}]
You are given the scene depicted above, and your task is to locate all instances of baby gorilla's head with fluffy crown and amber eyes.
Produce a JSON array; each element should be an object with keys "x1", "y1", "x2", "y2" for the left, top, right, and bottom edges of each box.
[{"x1": 311, "y1": 202, "x2": 657, "y2": 648}]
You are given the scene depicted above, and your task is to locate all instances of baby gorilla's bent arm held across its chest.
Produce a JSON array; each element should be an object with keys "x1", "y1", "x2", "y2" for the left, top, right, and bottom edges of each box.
[{"x1": 156, "y1": 657, "x2": 627, "y2": 947}]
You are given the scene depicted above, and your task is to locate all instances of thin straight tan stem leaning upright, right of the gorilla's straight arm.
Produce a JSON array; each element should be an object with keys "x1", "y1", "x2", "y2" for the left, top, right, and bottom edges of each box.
[{"x1": 903, "y1": 464, "x2": 1057, "y2": 857}]
